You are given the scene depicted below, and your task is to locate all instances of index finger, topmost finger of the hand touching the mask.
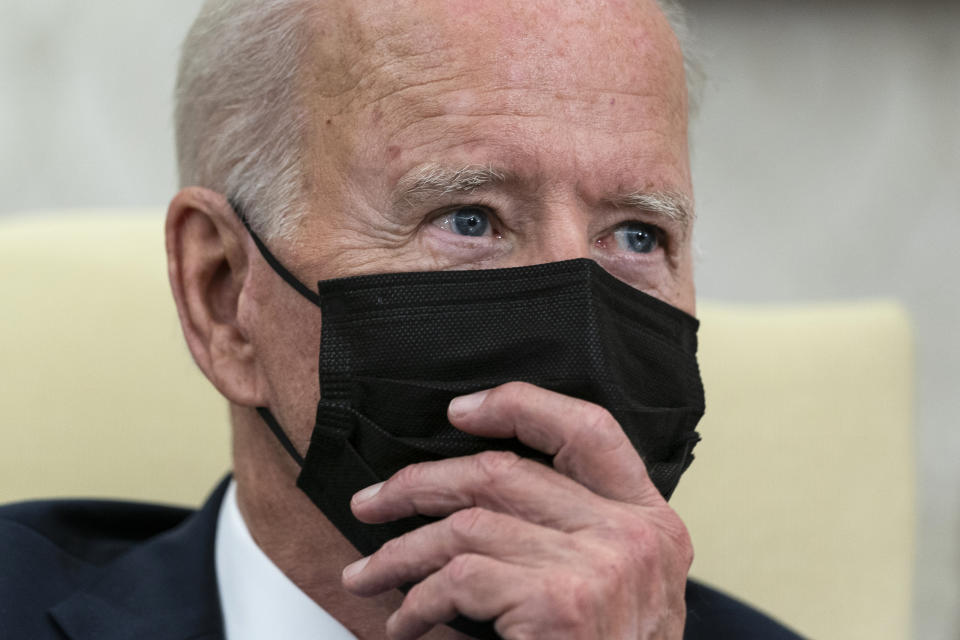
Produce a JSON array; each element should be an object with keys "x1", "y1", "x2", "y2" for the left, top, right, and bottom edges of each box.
[{"x1": 447, "y1": 382, "x2": 663, "y2": 504}]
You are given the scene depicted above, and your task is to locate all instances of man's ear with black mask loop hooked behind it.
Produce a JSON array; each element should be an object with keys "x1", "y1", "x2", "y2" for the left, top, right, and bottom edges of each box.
[{"x1": 166, "y1": 187, "x2": 265, "y2": 406}]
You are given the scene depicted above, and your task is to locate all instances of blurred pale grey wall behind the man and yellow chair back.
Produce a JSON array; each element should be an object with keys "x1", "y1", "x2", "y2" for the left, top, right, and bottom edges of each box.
[{"x1": 0, "y1": 0, "x2": 960, "y2": 639}]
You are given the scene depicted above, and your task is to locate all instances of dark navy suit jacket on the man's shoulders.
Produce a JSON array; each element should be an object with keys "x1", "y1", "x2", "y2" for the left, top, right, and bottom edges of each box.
[{"x1": 0, "y1": 480, "x2": 798, "y2": 640}]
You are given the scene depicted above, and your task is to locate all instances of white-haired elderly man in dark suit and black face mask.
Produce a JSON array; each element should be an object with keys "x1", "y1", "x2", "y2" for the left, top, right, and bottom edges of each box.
[{"x1": 0, "y1": 0, "x2": 794, "y2": 640}]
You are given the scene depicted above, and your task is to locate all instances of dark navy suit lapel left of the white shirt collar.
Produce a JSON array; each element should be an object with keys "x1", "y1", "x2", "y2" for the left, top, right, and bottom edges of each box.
[{"x1": 50, "y1": 477, "x2": 229, "y2": 640}]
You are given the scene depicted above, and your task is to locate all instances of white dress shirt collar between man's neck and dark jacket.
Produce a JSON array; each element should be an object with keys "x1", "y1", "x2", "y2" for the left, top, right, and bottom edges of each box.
[{"x1": 215, "y1": 480, "x2": 357, "y2": 640}]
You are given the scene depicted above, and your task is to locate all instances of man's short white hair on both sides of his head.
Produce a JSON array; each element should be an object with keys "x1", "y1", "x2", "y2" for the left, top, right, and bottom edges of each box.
[{"x1": 174, "y1": 0, "x2": 697, "y2": 239}]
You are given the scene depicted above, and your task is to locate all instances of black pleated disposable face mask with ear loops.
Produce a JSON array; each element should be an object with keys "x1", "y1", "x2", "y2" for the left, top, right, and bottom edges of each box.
[{"x1": 236, "y1": 208, "x2": 704, "y2": 637}]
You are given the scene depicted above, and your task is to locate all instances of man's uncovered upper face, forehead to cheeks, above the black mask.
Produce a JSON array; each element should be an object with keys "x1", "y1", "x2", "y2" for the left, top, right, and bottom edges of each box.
[{"x1": 274, "y1": 0, "x2": 694, "y2": 313}]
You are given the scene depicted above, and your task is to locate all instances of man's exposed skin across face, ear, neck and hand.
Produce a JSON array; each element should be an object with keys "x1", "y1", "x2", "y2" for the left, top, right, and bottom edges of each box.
[{"x1": 167, "y1": 0, "x2": 694, "y2": 639}]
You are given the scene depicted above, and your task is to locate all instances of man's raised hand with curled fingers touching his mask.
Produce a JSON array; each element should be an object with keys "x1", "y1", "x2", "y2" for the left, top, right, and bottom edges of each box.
[{"x1": 343, "y1": 382, "x2": 693, "y2": 640}]
